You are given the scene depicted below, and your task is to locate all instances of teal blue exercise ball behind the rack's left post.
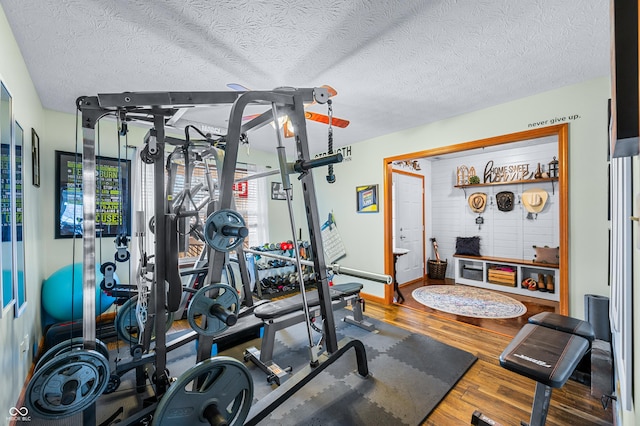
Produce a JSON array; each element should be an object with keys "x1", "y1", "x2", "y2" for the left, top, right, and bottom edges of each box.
[{"x1": 42, "y1": 263, "x2": 120, "y2": 321}]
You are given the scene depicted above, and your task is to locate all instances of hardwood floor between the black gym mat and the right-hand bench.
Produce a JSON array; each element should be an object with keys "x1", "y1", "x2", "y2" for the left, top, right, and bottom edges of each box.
[{"x1": 365, "y1": 302, "x2": 613, "y2": 426}]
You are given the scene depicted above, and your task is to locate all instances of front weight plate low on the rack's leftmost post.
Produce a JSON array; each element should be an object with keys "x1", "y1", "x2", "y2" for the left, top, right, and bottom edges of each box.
[{"x1": 25, "y1": 349, "x2": 110, "y2": 419}]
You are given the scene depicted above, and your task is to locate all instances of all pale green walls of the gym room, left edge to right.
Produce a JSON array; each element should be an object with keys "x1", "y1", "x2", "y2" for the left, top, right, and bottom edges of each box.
[{"x1": 0, "y1": 1, "x2": 640, "y2": 425}]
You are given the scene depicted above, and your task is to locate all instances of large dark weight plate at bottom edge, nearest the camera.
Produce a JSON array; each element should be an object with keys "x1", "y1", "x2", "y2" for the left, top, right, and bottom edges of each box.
[{"x1": 152, "y1": 356, "x2": 253, "y2": 426}]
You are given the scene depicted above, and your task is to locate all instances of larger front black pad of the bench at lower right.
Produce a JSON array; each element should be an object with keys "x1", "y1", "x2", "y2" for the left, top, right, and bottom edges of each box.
[{"x1": 500, "y1": 324, "x2": 589, "y2": 388}]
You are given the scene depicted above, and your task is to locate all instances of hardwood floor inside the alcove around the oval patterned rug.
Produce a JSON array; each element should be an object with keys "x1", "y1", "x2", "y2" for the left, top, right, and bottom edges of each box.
[{"x1": 400, "y1": 279, "x2": 558, "y2": 336}]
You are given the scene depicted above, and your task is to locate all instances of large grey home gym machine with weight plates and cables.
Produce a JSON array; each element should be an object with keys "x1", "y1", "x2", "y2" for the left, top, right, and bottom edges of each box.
[{"x1": 25, "y1": 88, "x2": 391, "y2": 425}]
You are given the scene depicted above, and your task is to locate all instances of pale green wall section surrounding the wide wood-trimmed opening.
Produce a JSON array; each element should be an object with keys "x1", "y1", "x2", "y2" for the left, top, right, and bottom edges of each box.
[{"x1": 316, "y1": 78, "x2": 610, "y2": 318}]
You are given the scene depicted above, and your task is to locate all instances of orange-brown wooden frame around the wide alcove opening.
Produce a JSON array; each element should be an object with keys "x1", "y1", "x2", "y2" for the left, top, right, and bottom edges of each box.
[{"x1": 383, "y1": 123, "x2": 569, "y2": 315}]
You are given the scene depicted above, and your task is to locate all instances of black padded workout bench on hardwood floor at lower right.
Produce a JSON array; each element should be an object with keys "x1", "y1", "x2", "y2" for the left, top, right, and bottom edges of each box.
[{"x1": 471, "y1": 312, "x2": 595, "y2": 426}]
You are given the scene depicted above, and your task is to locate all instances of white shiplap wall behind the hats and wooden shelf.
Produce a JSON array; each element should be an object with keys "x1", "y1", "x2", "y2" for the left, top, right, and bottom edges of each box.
[{"x1": 425, "y1": 140, "x2": 560, "y2": 278}]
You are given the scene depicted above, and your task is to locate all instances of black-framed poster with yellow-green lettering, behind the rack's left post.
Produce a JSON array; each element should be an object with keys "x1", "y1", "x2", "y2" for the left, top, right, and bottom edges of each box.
[{"x1": 55, "y1": 151, "x2": 131, "y2": 238}]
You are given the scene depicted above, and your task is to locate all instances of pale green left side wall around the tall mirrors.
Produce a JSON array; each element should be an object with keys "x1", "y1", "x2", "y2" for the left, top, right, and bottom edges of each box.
[{"x1": 0, "y1": 8, "x2": 47, "y2": 421}]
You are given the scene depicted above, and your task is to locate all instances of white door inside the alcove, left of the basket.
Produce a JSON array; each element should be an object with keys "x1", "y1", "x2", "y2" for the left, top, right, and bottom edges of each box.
[{"x1": 393, "y1": 171, "x2": 424, "y2": 284}]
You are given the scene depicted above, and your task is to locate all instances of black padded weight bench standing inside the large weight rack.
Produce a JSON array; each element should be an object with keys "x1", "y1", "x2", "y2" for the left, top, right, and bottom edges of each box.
[{"x1": 244, "y1": 283, "x2": 375, "y2": 385}]
